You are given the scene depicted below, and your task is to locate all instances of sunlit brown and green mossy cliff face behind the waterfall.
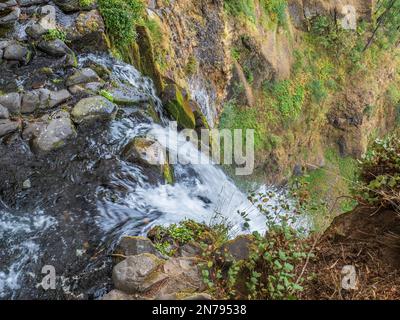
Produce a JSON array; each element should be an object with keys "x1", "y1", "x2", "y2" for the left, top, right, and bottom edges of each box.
[{"x1": 143, "y1": 0, "x2": 397, "y2": 182}]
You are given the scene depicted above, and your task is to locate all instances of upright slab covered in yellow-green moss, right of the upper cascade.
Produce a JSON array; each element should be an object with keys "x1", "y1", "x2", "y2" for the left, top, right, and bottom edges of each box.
[{"x1": 162, "y1": 84, "x2": 196, "y2": 129}]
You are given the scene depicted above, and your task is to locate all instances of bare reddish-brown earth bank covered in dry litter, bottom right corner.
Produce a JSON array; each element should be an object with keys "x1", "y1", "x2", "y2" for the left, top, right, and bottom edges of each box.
[{"x1": 302, "y1": 207, "x2": 400, "y2": 300}]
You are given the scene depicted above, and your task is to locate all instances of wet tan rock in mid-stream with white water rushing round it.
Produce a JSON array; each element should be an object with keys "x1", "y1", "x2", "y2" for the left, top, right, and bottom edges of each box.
[{"x1": 122, "y1": 137, "x2": 166, "y2": 165}]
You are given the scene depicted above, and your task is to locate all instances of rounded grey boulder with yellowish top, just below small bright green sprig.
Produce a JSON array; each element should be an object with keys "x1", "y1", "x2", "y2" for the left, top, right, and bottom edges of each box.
[{"x1": 71, "y1": 96, "x2": 118, "y2": 123}]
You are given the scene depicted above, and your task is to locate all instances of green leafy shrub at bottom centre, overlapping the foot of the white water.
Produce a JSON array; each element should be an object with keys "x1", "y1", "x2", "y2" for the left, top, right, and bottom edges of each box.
[{"x1": 201, "y1": 192, "x2": 313, "y2": 299}]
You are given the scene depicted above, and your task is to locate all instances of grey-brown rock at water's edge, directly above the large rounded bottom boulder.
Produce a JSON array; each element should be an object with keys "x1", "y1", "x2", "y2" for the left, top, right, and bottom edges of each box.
[{"x1": 115, "y1": 236, "x2": 163, "y2": 258}]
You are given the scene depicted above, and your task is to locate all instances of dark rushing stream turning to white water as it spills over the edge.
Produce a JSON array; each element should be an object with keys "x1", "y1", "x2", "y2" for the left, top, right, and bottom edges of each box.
[{"x1": 0, "y1": 55, "x2": 290, "y2": 299}]
